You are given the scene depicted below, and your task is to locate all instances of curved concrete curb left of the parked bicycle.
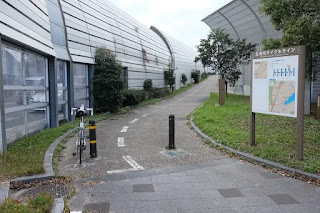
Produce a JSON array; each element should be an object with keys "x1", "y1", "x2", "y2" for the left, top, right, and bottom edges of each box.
[{"x1": 10, "y1": 127, "x2": 78, "y2": 184}]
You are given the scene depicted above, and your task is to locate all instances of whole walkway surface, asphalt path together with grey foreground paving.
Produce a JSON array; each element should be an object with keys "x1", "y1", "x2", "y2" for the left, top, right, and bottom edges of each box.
[{"x1": 59, "y1": 76, "x2": 320, "y2": 213}]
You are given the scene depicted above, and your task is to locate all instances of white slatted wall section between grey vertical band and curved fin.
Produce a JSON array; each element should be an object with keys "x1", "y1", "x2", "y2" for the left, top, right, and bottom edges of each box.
[{"x1": 61, "y1": 0, "x2": 170, "y2": 89}]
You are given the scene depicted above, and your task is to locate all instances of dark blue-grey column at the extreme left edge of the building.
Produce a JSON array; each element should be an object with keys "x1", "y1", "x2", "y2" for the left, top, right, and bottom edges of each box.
[{"x1": 0, "y1": 34, "x2": 7, "y2": 154}]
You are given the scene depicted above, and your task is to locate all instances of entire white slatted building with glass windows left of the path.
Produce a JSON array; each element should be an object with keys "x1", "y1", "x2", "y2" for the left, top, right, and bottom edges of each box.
[{"x1": 0, "y1": 0, "x2": 202, "y2": 150}]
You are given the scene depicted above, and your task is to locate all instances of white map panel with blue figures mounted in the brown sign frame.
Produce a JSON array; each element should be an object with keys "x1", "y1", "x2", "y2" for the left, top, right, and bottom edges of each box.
[{"x1": 252, "y1": 55, "x2": 299, "y2": 117}]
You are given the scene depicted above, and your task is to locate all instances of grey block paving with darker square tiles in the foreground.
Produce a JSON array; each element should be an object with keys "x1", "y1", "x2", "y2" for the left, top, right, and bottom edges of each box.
[{"x1": 70, "y1": 158, "x2": 320, "y2": 213}]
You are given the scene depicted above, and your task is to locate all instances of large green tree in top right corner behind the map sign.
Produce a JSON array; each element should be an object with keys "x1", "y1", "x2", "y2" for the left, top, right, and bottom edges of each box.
[{"x1": 260, "y1": 0, "x2": 320, "y2": 80}]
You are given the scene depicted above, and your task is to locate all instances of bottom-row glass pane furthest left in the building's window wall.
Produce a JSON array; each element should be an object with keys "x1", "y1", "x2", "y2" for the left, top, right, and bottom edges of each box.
[{"x1": 5, "y1": 111, "x2": 26, "y2": 143}]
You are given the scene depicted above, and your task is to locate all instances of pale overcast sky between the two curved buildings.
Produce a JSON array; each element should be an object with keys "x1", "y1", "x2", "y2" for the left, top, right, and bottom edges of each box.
[{"x1": 109, "y1": 0, "x2": 231, "y2": 48}]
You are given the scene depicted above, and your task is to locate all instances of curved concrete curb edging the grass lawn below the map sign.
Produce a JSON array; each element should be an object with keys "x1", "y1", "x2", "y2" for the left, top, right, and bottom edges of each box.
[{"x1": 190, "y1": 116, "x2": 320, "y2": 180}]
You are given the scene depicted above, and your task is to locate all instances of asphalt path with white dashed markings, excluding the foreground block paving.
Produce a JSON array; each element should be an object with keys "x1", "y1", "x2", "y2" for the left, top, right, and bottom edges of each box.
[{"x1": 59, "y1": 76, "x2": 222, "y2": 178}]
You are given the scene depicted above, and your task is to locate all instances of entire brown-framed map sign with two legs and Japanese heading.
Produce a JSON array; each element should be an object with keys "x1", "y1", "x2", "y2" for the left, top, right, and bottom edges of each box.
[{"x1": 250, "y1": 46, "x2": 306, "y2": 160}]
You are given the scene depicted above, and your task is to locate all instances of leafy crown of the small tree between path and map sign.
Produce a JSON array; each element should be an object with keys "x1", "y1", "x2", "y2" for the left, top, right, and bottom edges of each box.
[{"x1": 195, "y1": 29, "x2": 256, "y2": 95}]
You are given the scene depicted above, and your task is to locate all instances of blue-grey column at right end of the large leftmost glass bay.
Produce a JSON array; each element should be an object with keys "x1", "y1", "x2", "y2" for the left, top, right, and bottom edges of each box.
[{"x1": 48, "y1": 56, "x2": 59, "y2": 128}]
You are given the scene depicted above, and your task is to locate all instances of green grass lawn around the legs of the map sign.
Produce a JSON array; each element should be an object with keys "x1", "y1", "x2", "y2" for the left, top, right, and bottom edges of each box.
[{"x1": 193, "y1": 93, "x2": 320, "y2": 174}]
